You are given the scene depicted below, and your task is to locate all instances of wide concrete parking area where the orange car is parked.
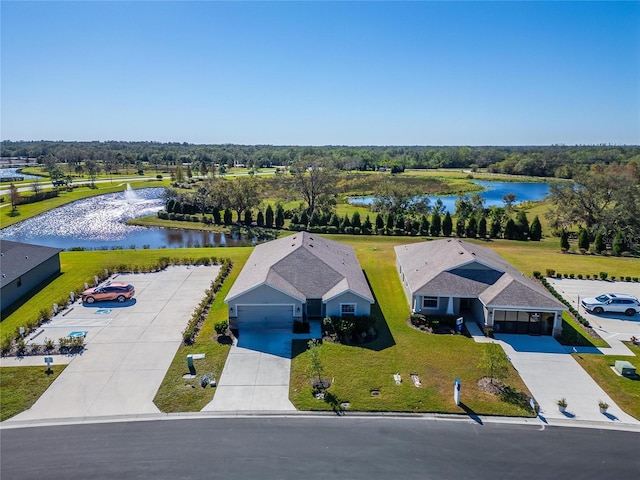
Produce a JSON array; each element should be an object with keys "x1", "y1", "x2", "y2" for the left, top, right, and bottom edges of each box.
[{"x1": 7, "y1": 266, "x2": 219, "y2": 422}]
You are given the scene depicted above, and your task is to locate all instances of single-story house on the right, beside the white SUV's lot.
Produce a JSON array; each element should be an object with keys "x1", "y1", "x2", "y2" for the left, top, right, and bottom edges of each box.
[{"x1": 395, "y1": 238, "x2": 567, "y2": 335}]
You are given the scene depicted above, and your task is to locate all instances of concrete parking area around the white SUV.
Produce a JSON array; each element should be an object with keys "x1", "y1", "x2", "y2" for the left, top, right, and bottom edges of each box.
[{"x1": 547, "y1": 278, "x2": 640, "y2": 355}]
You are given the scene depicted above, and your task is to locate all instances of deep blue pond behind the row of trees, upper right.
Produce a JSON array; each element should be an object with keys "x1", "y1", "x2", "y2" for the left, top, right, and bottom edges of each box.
[{"x1": 349, "y1": 180, "x2": 549, "y2": 213}]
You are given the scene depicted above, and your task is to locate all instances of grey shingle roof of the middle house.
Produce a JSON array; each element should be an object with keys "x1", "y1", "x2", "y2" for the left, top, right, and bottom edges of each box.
[{"x1": 225, "y1": 232, "x2": 374, "y2": 303}]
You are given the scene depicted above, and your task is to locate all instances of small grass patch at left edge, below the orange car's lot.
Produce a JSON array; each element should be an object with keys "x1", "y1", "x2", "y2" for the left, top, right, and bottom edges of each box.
[{"x1": 0, "y1": 365, "x2": 66, "y2": 422}]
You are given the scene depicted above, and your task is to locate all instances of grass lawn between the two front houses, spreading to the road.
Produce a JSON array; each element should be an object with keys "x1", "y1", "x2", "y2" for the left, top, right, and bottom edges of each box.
[{"x1": 290, "y1": 236, "x2": 531, "y2": 416}]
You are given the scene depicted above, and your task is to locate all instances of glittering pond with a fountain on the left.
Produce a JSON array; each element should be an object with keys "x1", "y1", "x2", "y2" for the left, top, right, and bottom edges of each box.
[{"x1": 0, "y1": 187, "x2": 257, "y2": 250}]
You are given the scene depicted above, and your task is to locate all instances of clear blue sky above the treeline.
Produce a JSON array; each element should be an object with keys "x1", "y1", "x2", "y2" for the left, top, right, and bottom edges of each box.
[{"x1": 0, "y1": 0, "x2": 640, "y2": 145}]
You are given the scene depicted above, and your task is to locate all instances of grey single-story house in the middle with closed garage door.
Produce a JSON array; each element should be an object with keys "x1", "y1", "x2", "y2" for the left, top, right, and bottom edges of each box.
[{"x1": 225, "y1": 232, "x2": 374, "y2": 331}]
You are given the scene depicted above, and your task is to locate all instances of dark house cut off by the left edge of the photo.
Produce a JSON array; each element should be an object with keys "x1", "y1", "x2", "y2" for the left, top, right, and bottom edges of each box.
[{"x1": 0, "y1": 240, "x2": 62, "y2": 316}]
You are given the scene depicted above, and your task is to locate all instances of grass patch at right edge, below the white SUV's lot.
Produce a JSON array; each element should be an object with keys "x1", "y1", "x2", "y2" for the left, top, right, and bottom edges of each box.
[{"x1": 573, "y1": 343, "x2": 640, "y2": 420}]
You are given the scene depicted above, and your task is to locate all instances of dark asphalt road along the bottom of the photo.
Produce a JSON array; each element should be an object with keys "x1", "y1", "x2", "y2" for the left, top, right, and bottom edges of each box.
[{"x1": 0, "y1": 417, "x2": 640, "y2": 480}]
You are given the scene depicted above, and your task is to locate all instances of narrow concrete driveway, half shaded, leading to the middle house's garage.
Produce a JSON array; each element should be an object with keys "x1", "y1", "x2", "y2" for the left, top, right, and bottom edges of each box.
[{"x1": 202, "y1": 330, "x2": 295, "y2": 411}]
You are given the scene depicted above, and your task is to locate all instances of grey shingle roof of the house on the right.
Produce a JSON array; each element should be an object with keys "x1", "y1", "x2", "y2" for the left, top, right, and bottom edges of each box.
[{"x1": 395, "y1": 239, "x2": 566, "y2": 310}]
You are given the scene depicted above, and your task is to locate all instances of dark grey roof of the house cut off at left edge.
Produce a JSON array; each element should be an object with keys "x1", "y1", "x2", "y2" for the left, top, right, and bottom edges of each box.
[{"x1": 0, "y1": 240, "x2": 62, "y2": 287}]
